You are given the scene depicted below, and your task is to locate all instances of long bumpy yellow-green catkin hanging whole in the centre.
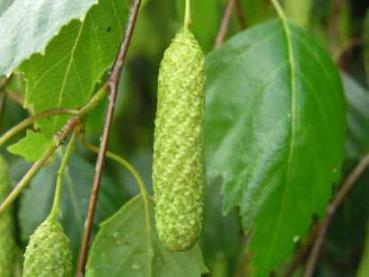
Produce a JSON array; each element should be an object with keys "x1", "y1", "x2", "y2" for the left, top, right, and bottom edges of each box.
[{"x1": 153, "y1": 29, "x2": 205, "y2": 251}]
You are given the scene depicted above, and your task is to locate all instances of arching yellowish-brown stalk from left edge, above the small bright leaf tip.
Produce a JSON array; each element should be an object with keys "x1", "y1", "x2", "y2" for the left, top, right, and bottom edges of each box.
[{"x1": 0, "y1": 109, "x2": 78, "y2": 146}]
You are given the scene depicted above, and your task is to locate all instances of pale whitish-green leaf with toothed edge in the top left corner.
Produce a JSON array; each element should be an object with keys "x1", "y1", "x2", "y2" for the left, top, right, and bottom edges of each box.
[{"x1": 0, "y1": 0, "x2": 97, "y2": 76}]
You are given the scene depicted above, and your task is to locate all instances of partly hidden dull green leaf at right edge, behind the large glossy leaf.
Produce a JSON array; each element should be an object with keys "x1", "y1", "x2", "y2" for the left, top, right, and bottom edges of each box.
[{"x1": 342, "y1": 74, "x2": 369, "y2": 160}]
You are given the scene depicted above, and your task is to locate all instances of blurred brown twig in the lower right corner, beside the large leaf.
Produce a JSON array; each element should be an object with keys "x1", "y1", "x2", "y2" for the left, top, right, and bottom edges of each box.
[{"x1": 304, "y1": 154, "x2": 369, "y2": 277}]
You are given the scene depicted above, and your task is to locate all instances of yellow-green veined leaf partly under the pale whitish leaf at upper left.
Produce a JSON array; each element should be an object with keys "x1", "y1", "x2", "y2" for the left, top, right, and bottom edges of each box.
[{"x1": 20, "y1": 0, "x2": 127, "y2": 142}]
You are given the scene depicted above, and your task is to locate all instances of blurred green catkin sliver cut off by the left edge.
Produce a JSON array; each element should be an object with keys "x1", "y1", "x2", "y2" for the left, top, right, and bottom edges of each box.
[{"x1": 0, "y1": 156, "x2": 16, "y2": 277}]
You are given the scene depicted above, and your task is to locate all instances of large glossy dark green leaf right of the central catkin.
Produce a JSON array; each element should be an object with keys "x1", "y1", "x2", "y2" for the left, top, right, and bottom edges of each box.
[{"x1": 205, "y1": 20, "x2": 346, "y2": 276}]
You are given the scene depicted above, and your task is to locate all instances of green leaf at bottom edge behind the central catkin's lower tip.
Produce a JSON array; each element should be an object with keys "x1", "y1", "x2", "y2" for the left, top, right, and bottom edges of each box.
[{"x1": 86, "y1": 196, "x2": 207, "y2": 277}]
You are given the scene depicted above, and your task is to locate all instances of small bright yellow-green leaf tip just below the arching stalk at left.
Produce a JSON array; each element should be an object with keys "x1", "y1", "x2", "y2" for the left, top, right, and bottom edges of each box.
[{"x1": 7, "y1": 130, "x2": 50, "y2": 162}]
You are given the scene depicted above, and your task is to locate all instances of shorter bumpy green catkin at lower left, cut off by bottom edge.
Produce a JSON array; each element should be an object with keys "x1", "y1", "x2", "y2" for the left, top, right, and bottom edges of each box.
[{"x1": 23, "y1": 217, "x2": 72, "y2": 277}]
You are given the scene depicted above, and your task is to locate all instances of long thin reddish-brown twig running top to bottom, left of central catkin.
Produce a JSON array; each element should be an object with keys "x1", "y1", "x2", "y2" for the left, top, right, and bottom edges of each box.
[{"x1": 77, "y1": 0, "x2": 141, "y2": 277}]
